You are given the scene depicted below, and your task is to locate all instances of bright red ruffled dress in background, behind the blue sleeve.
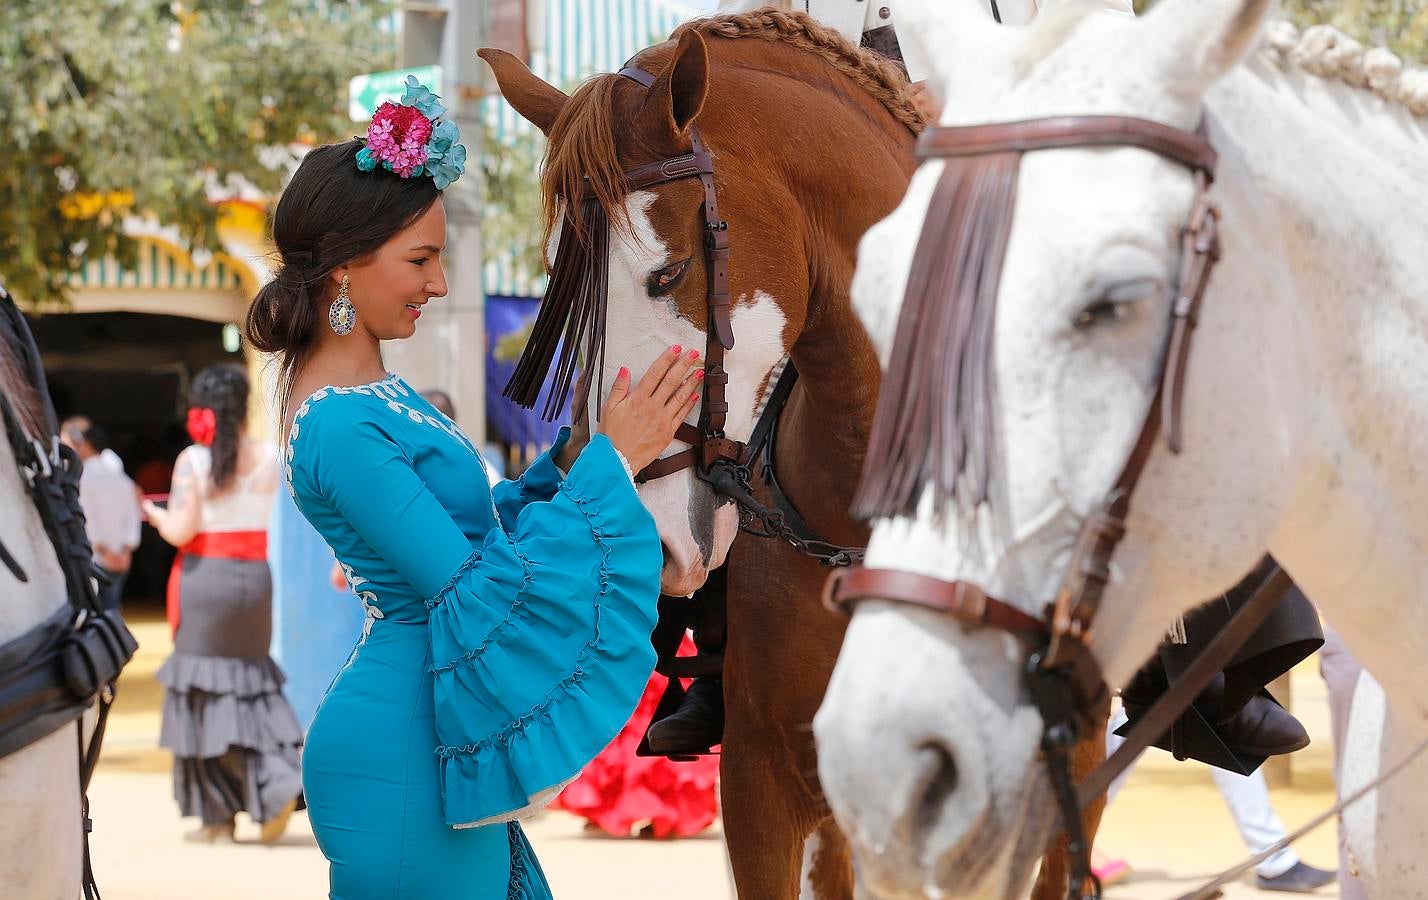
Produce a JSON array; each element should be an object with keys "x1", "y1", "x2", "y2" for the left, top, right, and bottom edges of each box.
[{"x1": 550, "y1": 634, "x2": 718, "y2": 839}]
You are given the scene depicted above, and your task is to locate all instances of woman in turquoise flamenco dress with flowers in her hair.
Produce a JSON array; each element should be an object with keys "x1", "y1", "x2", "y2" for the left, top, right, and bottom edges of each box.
[{"x1": 246, "y1": 81, "x2": 701, "y2": 900}]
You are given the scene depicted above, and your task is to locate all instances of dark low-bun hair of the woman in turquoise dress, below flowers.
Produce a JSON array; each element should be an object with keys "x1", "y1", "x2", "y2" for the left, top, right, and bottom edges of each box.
[{"x1": 244, "y1": 140, "x2": 441, "y2": 416}]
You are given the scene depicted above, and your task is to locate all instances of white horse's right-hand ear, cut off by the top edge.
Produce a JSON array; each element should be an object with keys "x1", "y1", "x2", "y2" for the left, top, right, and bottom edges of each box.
[{"x1": 1141, "y1": 0, "x2": 1274, "y2": 96}]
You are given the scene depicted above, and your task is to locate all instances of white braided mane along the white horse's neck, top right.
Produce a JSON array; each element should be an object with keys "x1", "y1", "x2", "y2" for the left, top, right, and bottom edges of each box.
[{"x1": 1261, "y1": 19, "x2": 1428, "y2": 116}]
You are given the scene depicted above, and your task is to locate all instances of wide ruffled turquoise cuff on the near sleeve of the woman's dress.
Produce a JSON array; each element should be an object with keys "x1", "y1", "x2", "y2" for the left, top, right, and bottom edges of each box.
[{"x1": 433, "y1": 436, "x2": 661, "y2": 826}]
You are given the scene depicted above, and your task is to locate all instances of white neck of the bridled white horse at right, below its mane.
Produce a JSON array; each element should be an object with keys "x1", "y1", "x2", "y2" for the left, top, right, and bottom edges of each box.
[{"x1": 1192, "y1": 57, "x2": 1428, "y2": 708}]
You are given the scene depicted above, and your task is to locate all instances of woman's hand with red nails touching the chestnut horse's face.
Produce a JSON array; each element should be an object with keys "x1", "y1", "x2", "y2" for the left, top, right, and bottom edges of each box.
[{"x1": 600, "y1": 347, "x2": 704, "y2": 471}]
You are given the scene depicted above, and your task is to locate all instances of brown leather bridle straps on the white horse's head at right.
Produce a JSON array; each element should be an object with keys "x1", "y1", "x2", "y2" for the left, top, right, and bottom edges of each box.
[{"x1": 824, "y1": 116, "x2": 1222, "y2": 896}]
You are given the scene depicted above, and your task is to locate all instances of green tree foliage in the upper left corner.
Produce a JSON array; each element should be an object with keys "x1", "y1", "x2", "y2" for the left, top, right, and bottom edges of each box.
[{"x1": 0, "y1": 0, "x2": 394, "y2": 301}]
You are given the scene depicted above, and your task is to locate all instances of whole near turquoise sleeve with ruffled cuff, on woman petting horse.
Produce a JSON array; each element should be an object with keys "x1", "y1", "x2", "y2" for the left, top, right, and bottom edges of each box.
[{"x1": 303, "y1": 407, "x2": 661, "y2": 826}]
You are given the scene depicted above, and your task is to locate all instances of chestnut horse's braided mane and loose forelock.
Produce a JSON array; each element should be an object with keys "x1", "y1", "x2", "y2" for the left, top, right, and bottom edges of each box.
[{"x1": 541, "y1": 9, "x2": 927, "y2": 254}]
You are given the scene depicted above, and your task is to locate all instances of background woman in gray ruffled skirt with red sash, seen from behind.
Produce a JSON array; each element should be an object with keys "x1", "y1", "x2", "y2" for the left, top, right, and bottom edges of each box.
[{"x1": 144, "y1": 366, "x2": 303, "y2": 843}]
